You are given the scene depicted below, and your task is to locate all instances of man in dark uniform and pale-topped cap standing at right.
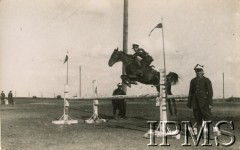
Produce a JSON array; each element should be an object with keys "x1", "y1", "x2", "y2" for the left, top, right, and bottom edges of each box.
[{"x1": 187, "y1": 64, "x2": 213, "y2": 130}]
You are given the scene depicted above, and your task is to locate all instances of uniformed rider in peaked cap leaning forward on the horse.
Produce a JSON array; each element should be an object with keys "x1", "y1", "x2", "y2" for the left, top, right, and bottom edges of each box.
[{"x1": 133, "y1": 44, "x2": 153, "y2": 75}]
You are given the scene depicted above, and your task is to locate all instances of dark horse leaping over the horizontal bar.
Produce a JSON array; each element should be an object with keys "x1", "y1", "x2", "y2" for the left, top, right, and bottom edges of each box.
[{"x1": 108, "y1": 48, "x2": 179, "y2": 115}]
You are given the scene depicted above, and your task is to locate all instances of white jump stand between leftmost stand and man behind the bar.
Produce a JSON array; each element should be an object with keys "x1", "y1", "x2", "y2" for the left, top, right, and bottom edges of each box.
[{"x1": 85, "y1": 80, "x2": 106, "y2": 123}]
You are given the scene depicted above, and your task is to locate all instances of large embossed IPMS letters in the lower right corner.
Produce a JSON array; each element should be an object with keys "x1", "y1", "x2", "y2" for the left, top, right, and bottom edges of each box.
[{"x1": 147, "y1": 121, "x2": 236, "y2": 147}]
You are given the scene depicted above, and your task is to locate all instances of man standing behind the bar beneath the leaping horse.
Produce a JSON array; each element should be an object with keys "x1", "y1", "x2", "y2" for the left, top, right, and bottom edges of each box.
[{"x1": 112, "y1": 83, "x2": 126, "y2": 119}]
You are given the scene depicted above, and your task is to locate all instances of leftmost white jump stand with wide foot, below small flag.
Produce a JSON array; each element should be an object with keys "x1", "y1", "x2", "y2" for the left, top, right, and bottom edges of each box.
[{"x1": 52, "y1": 84, "x2": 78, "y2": 124}]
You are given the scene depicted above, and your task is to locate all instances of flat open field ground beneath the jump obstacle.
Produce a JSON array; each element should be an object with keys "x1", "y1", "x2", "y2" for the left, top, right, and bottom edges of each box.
[{"x1": 1, "y1": 99, "x2": 240, "y2": 150}]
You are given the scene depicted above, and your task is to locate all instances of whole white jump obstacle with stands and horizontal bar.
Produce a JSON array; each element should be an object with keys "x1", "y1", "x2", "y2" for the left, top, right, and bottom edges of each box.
[{"x1": 52, "y1": 71, "x2": 187, "y2": 139}]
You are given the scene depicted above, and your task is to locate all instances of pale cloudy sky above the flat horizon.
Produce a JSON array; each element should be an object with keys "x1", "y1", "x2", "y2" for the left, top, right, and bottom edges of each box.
[{"x1": 0, "y1": 0, "x2": 240, "y2": 98}]
